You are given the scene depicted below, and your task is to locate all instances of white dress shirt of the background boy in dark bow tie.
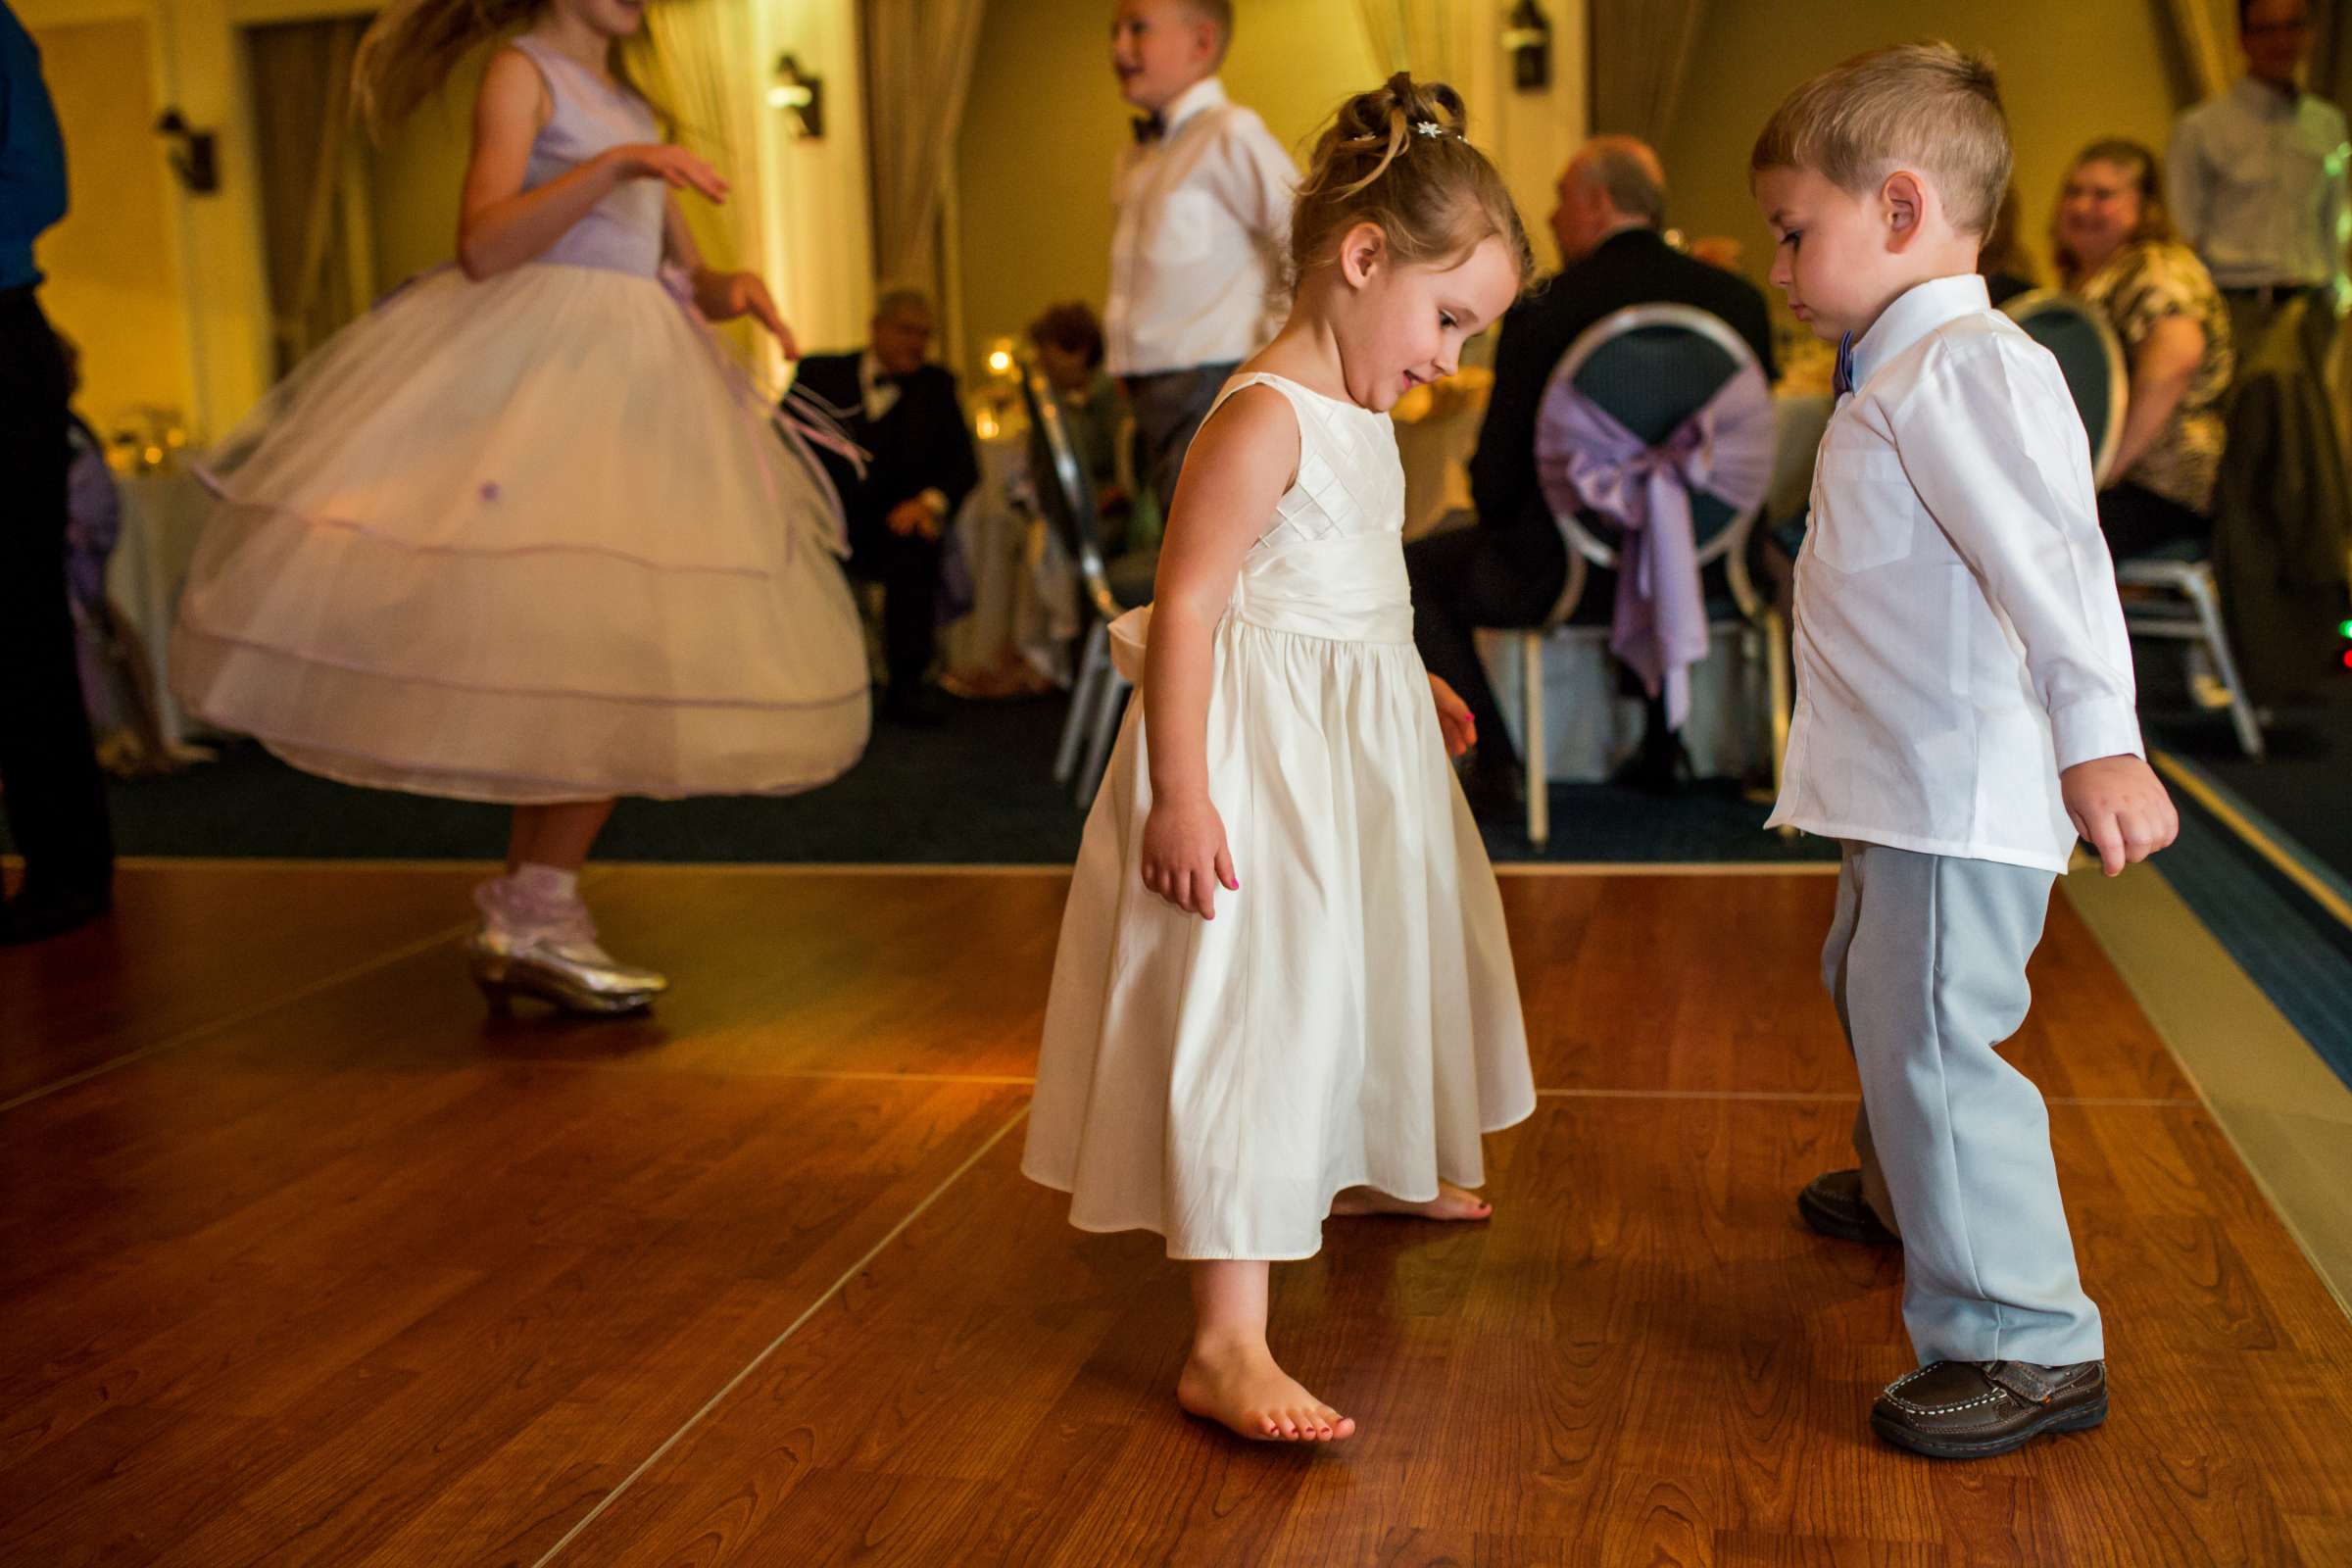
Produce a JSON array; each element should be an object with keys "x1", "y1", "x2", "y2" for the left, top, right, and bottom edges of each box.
[{"x1": 1103, "y1": 77, "x2": 1298, "y2": 376}]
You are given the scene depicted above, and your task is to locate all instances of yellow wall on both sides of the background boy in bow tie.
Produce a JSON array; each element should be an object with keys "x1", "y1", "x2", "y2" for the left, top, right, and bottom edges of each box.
[{"x1": 955, "y1": 0, "x2": 1381, "y2": 365}]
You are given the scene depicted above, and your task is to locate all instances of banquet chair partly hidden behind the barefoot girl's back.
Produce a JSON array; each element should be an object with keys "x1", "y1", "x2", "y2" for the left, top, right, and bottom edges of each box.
[{"x1": 1021, "y1": 365, "x2": 1159, "y2": 807}]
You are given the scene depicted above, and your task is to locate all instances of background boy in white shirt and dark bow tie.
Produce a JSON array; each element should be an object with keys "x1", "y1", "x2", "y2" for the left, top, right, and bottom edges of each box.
[{"x1": 1103, "y1": 0, "x2": 1298, "y2": 517}]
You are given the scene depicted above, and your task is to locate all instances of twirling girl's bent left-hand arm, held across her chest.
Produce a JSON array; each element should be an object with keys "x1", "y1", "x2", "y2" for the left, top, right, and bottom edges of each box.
[{"x1": 457, "y1": 49, "x2": 727, "y2": 279}]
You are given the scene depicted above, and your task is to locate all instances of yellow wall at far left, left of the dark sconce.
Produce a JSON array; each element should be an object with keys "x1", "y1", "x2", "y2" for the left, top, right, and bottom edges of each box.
[{"x1": 35, "y1": 17, "x2": 188, "y2": 435}]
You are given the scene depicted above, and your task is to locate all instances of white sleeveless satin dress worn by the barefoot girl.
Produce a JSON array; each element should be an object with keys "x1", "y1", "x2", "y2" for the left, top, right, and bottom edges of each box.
[{"x1": 1021, "y1": 371, "x2": 1536, "y2": 1260}]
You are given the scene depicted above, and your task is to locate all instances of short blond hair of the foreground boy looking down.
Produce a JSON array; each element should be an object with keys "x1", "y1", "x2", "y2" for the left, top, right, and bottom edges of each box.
[{"x1": 1747, "y1": 42, "x2": 2011, "y2": 237}]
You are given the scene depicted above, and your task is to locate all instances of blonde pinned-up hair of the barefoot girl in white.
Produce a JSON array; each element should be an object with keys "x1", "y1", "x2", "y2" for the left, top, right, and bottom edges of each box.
[{"x1": 1292, "y1": 71, "x2": 1536, "y2": 289}]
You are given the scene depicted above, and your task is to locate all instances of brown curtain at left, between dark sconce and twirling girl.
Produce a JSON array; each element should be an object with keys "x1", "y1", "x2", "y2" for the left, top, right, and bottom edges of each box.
[{"x1": 245, "y1": 17, "x2": 367, "y2": 373}]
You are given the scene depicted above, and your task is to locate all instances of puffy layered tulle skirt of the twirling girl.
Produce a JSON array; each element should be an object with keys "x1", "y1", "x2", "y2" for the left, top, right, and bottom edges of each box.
[{"x1": 172, "y1": 264, "x2": 868, "y2": 804}]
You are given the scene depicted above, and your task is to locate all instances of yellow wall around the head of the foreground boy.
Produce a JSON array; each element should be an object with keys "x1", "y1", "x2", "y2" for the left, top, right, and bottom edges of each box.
[{"x1": 1660, "y1": 0, "x2": 2182, "y2": 301}]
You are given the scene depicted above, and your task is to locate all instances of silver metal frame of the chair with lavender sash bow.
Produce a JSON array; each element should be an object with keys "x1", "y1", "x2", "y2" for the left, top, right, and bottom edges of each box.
[{"x1": 1505, "y1": 303, "x2": 1789, "y2": 849}]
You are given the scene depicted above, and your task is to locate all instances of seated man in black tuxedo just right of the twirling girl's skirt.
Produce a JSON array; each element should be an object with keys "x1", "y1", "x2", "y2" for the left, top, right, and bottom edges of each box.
[{"x1": 798, "y1": 289, "x2": 981, "y2": 724}]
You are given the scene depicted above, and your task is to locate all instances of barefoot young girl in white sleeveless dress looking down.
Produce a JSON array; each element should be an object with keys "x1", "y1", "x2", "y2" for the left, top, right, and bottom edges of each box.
[{"x1": 1023, "y1": 75, "x2": 1536, "y2": 1441}]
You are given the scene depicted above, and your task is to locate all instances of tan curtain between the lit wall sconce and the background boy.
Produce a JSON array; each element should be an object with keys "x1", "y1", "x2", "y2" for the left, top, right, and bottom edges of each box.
[{"x1": 865, "y1": 0, "x2": 986, "y2": 289}]
